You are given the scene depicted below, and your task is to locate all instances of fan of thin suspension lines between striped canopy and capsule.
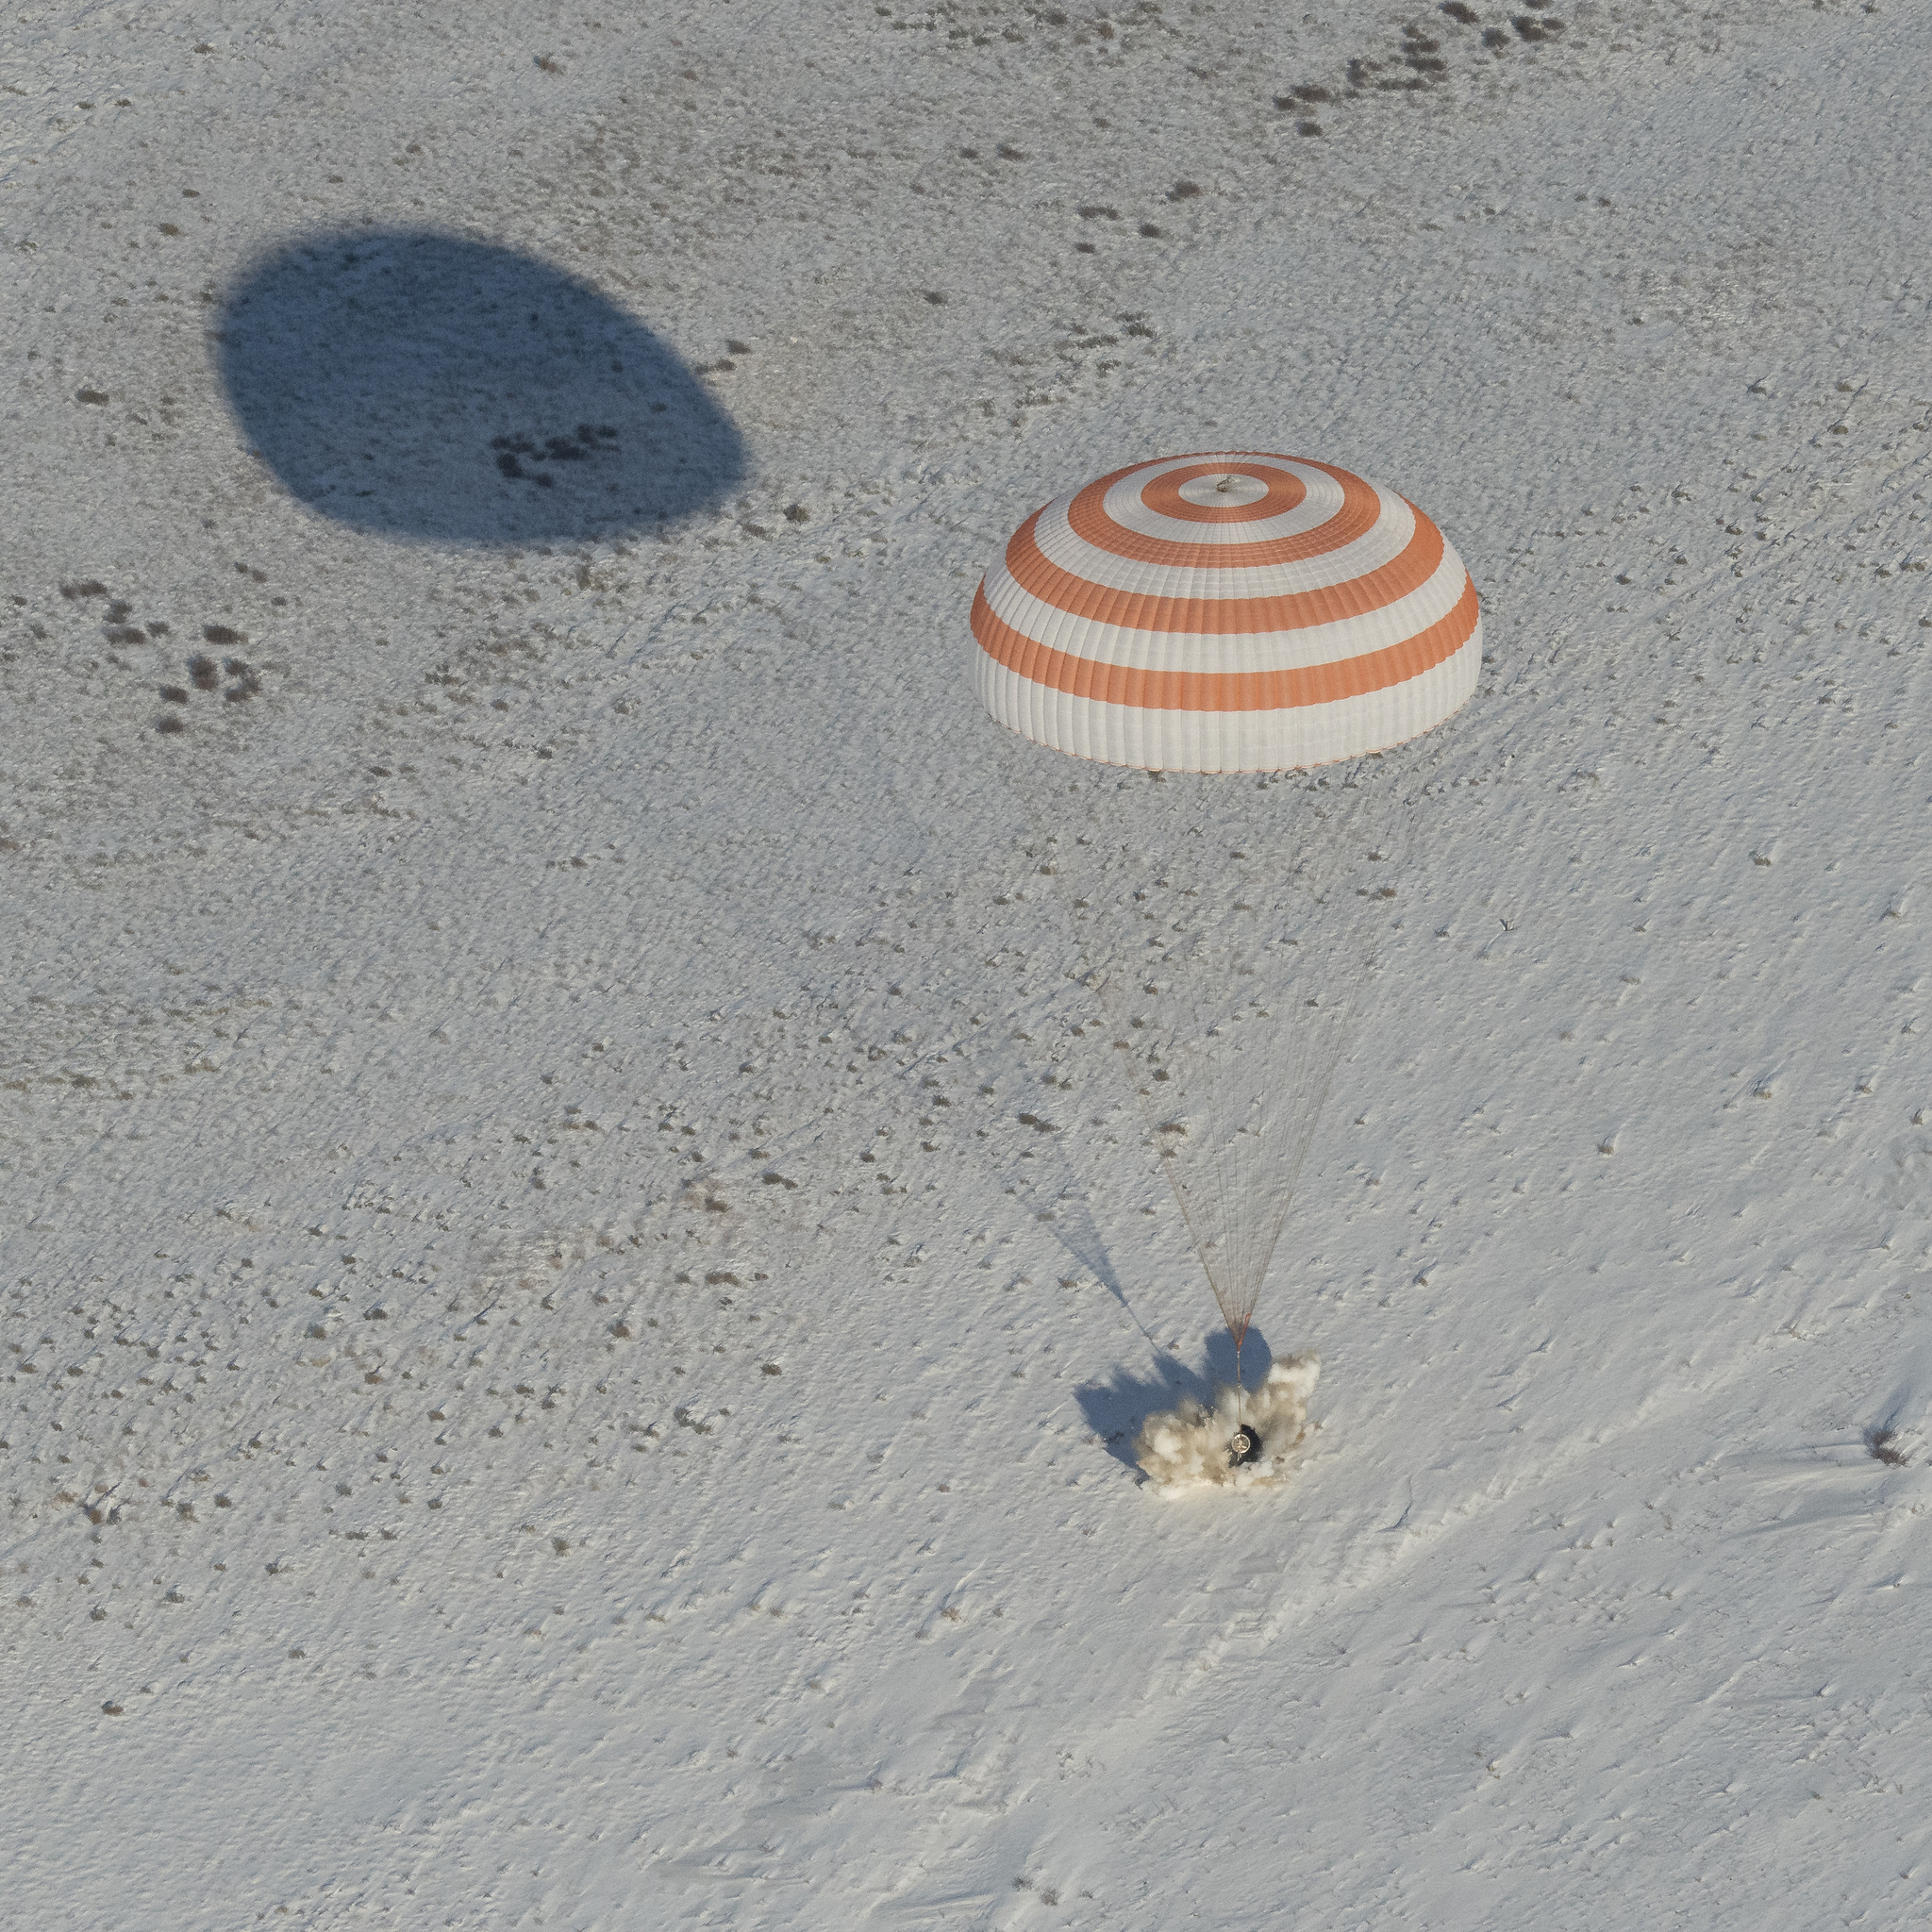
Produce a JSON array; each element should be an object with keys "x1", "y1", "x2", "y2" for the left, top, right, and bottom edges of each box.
[{"x1": 1028, "y1": 773, "x2": 1408, "y2": 1458}]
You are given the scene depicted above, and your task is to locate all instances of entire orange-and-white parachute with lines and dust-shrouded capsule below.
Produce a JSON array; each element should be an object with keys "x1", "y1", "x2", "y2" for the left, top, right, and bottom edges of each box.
[{"x1": 974, "y1": 452, "x2": 1482, "y2": 1486}]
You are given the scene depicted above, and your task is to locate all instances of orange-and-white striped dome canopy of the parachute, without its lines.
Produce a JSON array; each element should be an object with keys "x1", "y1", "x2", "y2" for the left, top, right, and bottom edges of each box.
[{"x1": 972, "y1": 450, "x2": 1482, "y2": 771}]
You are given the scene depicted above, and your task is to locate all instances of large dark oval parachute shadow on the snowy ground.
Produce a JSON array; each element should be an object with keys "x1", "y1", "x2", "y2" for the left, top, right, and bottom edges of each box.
[{"x1": 218, "y1": 228, "x2": 746, "y2": 545}]
